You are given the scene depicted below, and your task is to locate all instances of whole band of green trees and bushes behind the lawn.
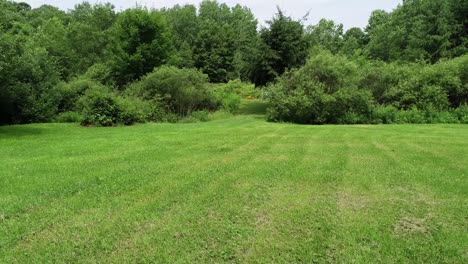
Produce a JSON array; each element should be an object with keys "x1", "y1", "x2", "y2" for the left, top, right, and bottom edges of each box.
[{"x1": 0, "y1": 0, "x2": 468, "y2": 126}]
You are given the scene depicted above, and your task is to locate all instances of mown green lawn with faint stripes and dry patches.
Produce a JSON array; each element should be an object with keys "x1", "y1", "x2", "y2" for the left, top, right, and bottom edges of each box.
[{"x1": 0, "y1": 115, "x2": 468, "y2": 263}]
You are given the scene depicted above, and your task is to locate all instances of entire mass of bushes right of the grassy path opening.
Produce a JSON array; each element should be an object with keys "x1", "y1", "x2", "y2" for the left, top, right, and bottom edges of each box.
[{"x1": 268, "y1": 51, "x2": 467, "y2": 124}]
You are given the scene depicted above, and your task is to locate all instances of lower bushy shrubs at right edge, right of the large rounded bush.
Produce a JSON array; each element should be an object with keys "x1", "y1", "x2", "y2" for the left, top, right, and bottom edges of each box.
[{"x1": 359, "y1": 55, "x2": 468, "y2": 112}]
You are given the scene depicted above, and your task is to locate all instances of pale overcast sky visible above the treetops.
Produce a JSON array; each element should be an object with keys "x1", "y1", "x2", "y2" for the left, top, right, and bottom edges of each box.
[{"x1": 22, "y1": 0, "x2": 402, "y2": 28}]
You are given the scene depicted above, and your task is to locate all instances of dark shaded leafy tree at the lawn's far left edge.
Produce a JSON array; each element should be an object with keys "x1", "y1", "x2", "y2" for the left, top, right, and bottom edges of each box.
[{"x1": 0, "y1": 33, "x2": 59, "y2": 124}]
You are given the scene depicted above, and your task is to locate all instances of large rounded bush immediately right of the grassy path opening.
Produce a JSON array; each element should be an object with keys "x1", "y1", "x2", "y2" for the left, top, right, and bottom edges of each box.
[{"x1": 267, "y1": 52, "x2": 374, "y2": 124}]
